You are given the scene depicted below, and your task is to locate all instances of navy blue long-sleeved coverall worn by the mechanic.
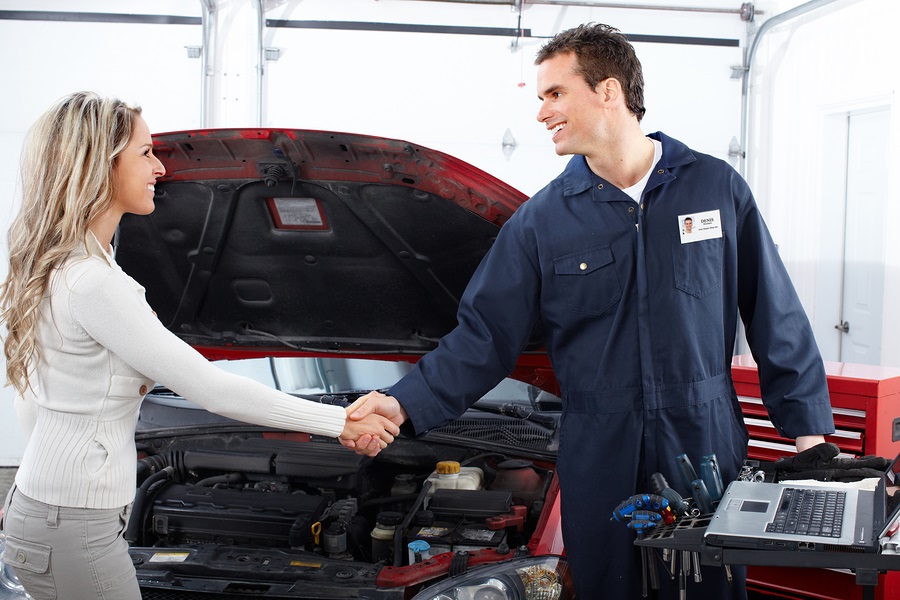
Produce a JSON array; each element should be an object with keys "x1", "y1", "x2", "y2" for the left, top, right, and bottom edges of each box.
[{"x1": 389, "y1": 133, "x2": 834, "y2": 600}]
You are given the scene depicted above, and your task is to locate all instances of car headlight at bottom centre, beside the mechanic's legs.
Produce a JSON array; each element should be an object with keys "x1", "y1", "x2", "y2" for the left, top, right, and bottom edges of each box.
[{"x1": 413, "y1": 556, "x2": 575, "y2": 600}]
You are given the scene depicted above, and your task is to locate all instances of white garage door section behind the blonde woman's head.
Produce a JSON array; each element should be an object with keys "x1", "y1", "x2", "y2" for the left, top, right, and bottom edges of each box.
[{"x1": 0, "y1": 0, "x2": 201, "y2": 466}]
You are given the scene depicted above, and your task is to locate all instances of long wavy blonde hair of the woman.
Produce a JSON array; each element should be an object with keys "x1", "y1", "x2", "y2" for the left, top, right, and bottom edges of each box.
[{"x1": 0, "y1": 92, "x2": 141, "y2": 393}]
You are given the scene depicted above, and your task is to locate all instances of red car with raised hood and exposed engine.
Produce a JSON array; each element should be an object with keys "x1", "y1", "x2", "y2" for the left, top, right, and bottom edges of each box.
[{"x1": 0, "y1": 129, "x2": 572, "y2": 600}]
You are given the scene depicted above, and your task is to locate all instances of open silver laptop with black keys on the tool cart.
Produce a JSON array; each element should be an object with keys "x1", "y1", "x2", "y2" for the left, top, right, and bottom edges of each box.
[{"x1": 703, "y1": 455, "x2": 900, "y2": 552}]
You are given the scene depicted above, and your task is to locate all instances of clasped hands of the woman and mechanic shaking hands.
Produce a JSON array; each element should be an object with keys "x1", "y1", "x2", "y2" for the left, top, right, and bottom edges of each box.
[{"x1": 338, "y1": 392, "x2": 408, "y2": 456}]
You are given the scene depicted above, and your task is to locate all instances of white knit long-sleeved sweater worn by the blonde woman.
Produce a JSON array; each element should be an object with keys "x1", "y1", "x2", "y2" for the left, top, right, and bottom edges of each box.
[{"x1": 16, "y1": 234, "x2": 345, "y2": 508}]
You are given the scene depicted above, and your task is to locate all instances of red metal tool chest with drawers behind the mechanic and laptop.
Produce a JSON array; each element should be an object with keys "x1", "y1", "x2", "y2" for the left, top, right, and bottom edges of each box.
[{"x1": 731, "y1": 355, "x2": 900, "y2": 600}]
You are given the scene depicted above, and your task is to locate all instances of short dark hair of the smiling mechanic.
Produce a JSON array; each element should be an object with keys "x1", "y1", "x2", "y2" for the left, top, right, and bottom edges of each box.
[{"x1": 534, "y1": 23, "x2": 647, "y2": 121}]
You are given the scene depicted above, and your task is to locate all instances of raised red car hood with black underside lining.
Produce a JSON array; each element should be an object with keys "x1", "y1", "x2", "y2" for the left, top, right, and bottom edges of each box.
[{"x1": 116, "y1": 129, "x2": 540, "y2": 358}]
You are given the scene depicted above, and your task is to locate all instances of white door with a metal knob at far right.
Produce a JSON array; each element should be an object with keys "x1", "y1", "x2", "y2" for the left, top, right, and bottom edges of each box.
[{"x1": 834, "y1": 109, "x2": 890, "y2": 365}]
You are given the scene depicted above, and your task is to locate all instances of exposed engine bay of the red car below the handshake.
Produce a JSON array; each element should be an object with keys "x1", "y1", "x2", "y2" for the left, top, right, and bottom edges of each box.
[{"x1": 125, "y1": 432, "x2": 554, "y2": 586}]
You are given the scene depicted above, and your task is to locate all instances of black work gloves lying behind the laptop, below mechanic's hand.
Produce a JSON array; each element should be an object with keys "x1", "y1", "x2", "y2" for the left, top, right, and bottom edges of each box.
[{"x1": 773, "y1": 442, "x2": 891, "y2": 481}]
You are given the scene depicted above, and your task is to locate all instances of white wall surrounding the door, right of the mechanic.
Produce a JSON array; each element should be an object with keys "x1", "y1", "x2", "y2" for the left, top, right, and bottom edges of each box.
[{"x1": 748, "y1": 0, "x2": 900, "y2": 366}]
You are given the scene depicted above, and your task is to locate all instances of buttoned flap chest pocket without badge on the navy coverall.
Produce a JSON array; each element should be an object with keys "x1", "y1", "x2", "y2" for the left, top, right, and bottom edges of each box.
[{"x1": 553, "y1": 246, "x2": 622, "y2": 315}]
